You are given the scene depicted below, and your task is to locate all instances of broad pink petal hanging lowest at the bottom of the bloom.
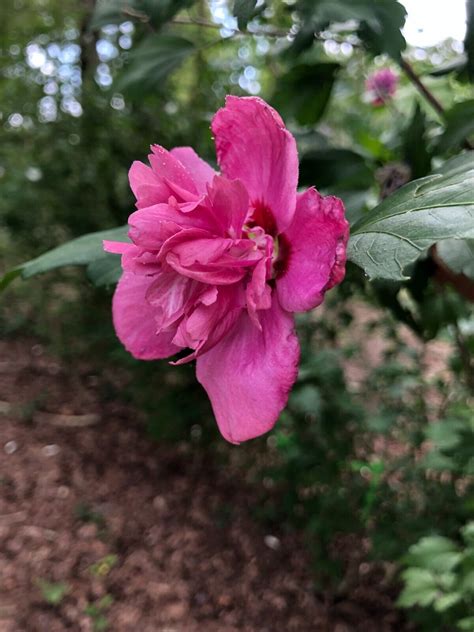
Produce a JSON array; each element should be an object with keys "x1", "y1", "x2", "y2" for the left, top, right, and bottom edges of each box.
[{"x1": 196, "y1": 296, "x2": 299, "y2": 443}]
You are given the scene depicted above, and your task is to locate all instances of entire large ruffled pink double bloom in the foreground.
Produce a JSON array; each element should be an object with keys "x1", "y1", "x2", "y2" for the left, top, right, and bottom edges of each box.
[{"x1": 105, "y1": 97, "x2": 348, "y2": 443}]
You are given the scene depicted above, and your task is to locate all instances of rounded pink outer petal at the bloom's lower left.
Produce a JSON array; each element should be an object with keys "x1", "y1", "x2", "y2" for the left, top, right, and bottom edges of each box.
[{"x1": 112, "y1": 272, "x2": 180, "y2": 360}]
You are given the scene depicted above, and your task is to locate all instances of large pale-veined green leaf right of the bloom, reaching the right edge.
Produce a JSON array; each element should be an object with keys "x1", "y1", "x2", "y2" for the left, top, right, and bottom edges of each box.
[{"x1": 348, "y1": 152, "x2": 474, "y2": 280}]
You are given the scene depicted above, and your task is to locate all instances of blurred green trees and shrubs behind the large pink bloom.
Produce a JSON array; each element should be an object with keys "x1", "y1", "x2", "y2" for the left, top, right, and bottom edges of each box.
[{"x1": 0, "y1": 0, "x2": 474, "y2": 631}]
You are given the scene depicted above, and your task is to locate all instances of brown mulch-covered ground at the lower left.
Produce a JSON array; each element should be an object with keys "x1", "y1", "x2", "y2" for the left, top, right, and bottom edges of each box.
[{"x1": 0, "y1": 340, "x2": 409, "y2": 632}]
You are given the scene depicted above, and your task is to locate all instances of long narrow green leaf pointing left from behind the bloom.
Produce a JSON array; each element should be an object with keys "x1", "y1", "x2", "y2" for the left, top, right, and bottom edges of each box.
[{"x1": 0, "y1": 226, "x2": 128, "y2": 290}]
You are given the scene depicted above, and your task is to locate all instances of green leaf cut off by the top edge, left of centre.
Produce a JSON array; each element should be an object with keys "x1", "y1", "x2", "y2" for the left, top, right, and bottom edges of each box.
[{"x1": 89, "y1": 0, "x2": 195, "y2": 30}]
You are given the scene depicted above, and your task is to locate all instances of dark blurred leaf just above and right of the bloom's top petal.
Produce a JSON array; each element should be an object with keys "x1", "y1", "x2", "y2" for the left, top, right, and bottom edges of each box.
[{"x1": 273, "y1": 63, "x2": 341, "y2": 125}]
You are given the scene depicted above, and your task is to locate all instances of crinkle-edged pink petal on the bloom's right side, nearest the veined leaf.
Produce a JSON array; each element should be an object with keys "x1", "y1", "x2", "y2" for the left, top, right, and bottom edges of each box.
[{"x1": 276, "y1": 189, "x2": 349, "y2": 312}]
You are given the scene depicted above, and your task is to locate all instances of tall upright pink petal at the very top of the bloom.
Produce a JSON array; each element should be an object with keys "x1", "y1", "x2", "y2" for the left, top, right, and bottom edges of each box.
[{"x1": 211, "y1": 96, "x2": 298, "y2": 232}]
